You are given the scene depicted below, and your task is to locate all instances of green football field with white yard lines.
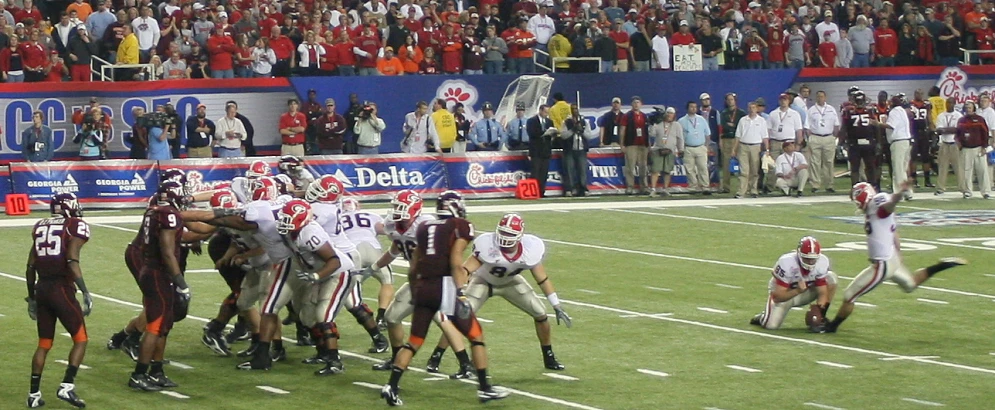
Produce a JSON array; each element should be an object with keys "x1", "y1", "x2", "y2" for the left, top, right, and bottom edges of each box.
[{"x1": 0, "y1": 194, "x2": 995, "y2": 410}]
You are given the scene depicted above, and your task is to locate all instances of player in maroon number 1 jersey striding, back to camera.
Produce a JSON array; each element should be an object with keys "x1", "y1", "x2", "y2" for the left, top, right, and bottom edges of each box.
[{"x1": 380, "y1": 197, "x2": 508, "y2": 406}]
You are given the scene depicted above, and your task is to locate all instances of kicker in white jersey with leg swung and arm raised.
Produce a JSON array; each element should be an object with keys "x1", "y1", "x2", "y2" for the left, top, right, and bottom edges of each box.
[{"x1": 825, "y1": 180, "x2": 967, "y2": 333}]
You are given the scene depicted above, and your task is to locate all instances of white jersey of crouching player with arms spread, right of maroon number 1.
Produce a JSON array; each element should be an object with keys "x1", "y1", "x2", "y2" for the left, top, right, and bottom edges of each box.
[{"x1": 471, "y1": 232, "x2": 546, "y2": 287}]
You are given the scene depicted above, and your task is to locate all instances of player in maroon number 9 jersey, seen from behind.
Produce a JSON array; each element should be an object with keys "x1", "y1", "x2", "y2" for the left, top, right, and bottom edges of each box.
[{"x1": 128, "y1": 181, "x2": 190, "y2": 391}]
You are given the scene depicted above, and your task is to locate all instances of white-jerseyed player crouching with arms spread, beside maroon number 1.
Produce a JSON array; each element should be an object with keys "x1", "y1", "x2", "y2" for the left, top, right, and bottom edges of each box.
[{"x1": 429, "y1": 214, "x2": 572, "y2": 370}]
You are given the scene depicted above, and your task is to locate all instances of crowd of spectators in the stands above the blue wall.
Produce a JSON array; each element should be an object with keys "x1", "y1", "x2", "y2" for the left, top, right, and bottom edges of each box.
[{"x1": 0, "y1": 0, "x2": 995, "y2": 82}]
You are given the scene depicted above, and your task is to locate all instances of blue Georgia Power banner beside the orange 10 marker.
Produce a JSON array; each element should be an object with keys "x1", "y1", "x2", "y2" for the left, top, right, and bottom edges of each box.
[{"x1": 10, "y1": 160, "x2": 159, "y2": 208}]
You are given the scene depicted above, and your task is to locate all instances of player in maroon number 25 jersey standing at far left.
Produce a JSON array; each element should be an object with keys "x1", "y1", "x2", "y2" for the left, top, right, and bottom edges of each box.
[{"x1": 25, "y1": 193, "x2": 93, "y2": 408}]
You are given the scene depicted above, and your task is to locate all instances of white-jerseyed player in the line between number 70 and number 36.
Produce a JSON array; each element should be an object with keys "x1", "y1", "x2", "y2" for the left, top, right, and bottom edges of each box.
[{"x1": 304, "y1": 175, "x2": 389, "y2": 363}]
